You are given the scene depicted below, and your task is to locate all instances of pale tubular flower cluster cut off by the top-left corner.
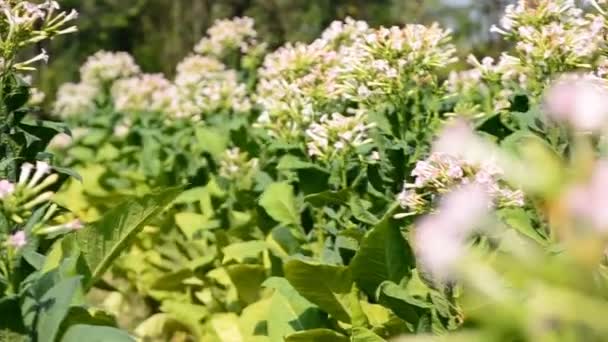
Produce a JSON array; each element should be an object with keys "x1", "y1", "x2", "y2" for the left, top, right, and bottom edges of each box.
[{"x1": 0, "y1": 0, "x2": 78, "y2": 70}]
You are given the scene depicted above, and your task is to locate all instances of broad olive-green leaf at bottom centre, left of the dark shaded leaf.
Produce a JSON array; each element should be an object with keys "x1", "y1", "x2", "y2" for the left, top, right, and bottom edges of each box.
[{"x1": 284, "y1": 259, "x2": 352, "y2": 323}]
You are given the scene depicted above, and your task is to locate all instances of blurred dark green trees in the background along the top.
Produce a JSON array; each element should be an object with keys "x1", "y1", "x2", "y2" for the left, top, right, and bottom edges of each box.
[{"x1": 38, "y1": 0, "x2": 512, "y2": 101}]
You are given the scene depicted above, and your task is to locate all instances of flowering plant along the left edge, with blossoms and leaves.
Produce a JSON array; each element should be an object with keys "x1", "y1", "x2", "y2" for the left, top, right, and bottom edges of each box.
[{"x1": 0, "y1": 0, "x2": 179, "y2": 341}]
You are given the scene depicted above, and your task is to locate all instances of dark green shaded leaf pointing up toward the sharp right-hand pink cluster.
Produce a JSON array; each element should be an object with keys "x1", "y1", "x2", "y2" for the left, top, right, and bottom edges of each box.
[{"x1": 350, "y1": 210, "x2": 414, "y2": 297}]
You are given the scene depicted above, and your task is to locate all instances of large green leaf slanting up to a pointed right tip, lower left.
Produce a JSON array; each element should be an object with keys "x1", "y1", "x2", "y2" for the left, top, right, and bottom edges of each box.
[{"x1": 77, "y1": 188, "x2": 182, "y2": 288}]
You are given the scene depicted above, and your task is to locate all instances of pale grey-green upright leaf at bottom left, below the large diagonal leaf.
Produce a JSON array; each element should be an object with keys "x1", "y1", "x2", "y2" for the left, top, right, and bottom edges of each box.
[{"x1": 36, "y1": 277, "x2": 81, "y2": 341}]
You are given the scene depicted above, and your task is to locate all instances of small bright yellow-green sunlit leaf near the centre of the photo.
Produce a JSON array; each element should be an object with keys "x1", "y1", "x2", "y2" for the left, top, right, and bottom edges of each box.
[{"x1": 260, "y1": 183, "x2": 300, "y2": 224}]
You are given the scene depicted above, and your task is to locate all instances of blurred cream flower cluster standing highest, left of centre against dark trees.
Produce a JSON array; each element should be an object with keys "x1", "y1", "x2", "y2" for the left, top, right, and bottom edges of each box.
[{"x1": 194, "y1": 17, "x2": 258, "y2": 59}]
